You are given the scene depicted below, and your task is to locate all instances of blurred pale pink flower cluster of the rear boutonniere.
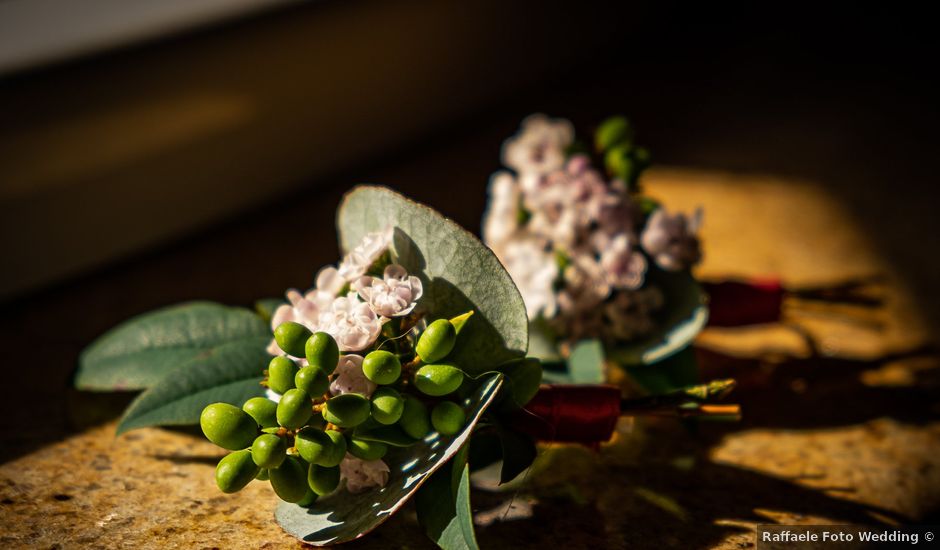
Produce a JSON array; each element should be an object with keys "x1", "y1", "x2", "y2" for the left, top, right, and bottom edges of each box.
[{"x1": 483, "y1": 114, "x2": 701, "y2": 340}]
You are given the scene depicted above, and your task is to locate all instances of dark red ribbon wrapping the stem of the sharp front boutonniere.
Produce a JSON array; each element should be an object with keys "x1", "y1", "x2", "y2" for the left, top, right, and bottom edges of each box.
[{"x1": 512, "y1": 384, "x2": 620, "y2": 444}]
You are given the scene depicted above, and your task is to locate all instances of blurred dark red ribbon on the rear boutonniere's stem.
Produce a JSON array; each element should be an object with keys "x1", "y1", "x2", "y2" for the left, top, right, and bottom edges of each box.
[{"x1": 704, "y1": 278, "x2": 785, "y2": 327}]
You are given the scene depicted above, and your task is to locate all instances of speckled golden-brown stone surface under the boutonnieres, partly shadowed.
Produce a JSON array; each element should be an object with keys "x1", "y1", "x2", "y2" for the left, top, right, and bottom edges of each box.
[{"x1": 0, "y1": 170, "x2": 940, "y2": 549}]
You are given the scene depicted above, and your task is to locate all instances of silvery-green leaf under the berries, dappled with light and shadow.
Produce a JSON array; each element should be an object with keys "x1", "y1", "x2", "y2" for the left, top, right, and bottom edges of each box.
[{"x1": 274, "y1": 374, "x2": 502, "y2": 546}]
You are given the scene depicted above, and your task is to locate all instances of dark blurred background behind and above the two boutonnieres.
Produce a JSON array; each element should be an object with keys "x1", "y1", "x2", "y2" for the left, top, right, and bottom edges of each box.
[{"x1": 0, "y1": 0, "x2": 940, "y2": 459}]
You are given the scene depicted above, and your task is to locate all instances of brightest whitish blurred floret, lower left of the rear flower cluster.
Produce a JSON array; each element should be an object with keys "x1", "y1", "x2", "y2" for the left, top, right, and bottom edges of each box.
[{"x1": 500, "y1": 239, "x2": 558, "y2": 319}]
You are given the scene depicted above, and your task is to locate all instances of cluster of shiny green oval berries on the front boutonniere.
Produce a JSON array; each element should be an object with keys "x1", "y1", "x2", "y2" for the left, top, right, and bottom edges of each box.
[{"x1": 199, "y1": 312, "x2": 473, "y2": 506}]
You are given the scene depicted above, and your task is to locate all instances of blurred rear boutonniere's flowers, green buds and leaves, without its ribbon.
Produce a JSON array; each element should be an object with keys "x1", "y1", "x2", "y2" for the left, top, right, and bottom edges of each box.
[{"x1": 483, "y1": 114, "x2": 707, "y2": 381}]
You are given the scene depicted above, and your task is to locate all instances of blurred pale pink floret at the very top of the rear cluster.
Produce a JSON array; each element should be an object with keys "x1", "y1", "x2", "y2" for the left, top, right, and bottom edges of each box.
[{"x1": 502, "y1": 114, "x2": 574, "y2": 174}]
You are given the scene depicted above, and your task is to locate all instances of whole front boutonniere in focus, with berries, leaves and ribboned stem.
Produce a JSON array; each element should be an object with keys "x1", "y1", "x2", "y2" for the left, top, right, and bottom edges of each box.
[{"x1": 76, "y1": 186, "x2": 737, "y2": 549}]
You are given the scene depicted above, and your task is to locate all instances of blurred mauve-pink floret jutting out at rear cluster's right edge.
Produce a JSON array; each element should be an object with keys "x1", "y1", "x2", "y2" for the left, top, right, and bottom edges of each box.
[{"x1": 640, "y1": 208, "x2": 702, "y2": 271}]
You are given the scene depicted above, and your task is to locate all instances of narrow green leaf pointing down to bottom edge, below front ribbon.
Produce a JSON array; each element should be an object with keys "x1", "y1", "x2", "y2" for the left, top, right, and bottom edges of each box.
[{"x1": 415, "y1": 442, "x2": 479, "y2": 550}]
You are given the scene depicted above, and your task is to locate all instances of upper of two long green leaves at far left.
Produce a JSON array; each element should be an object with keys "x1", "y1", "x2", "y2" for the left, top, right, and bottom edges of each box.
[{"x1": 75, "y1": 302, "x2": 271, "y2": 391}]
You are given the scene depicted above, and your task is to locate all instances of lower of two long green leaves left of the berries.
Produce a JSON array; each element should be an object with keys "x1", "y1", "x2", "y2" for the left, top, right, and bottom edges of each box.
[{"x1": 118, "y1": 336, "x2": 271, "y2": 434}]
